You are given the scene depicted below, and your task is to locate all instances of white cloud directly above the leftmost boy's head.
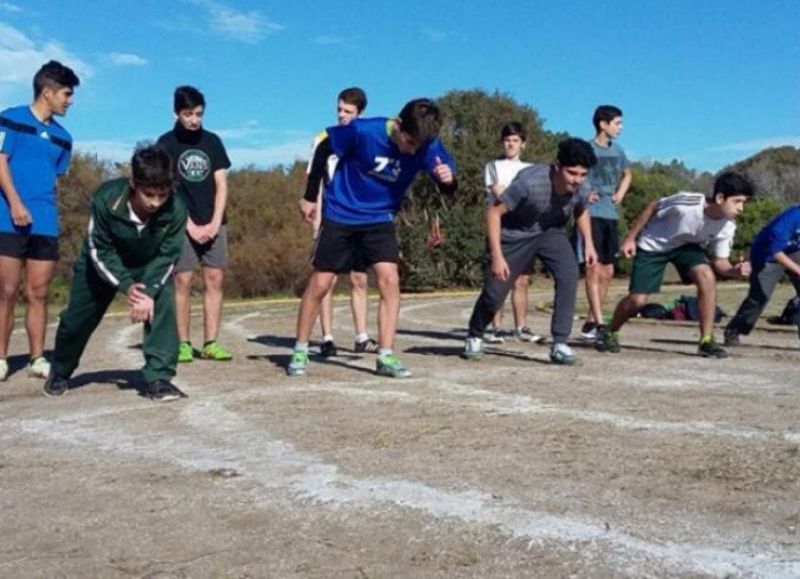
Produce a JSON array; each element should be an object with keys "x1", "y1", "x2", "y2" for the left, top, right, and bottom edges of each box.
[{"x1": 0, "y1": 22, "x2": 93, "y2": 91}]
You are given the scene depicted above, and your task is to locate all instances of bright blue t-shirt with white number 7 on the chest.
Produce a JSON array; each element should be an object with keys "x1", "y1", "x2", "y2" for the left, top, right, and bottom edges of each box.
[{"x1": 322, "y1": 117, "x2": 455, "y2": 225}]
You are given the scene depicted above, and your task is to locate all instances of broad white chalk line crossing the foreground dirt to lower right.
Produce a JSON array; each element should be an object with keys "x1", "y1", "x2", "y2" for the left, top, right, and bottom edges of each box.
[{"x1": 21, "y1": 401, "x2": 800, "y2": 578}]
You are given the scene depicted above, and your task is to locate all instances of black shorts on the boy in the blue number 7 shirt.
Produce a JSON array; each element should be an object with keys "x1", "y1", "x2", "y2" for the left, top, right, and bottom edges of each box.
[{"x1": 311, "y1": 220, "x2": 400, "y2": 273}]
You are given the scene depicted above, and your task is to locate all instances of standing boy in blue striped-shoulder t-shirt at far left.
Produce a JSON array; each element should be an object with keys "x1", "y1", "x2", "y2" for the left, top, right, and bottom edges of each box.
[{"x1": 0, "y1": 60, "x2": 80, "y2": 380}]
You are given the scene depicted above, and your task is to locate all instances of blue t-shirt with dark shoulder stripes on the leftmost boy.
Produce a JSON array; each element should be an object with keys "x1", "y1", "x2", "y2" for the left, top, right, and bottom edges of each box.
[{"x1": 0, "y1": 106, "x2": 72, "y2": 236}]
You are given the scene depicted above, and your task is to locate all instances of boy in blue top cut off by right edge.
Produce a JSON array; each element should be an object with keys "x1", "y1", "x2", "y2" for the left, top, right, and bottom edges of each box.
[{"x1": 725, "y1": 205, "x2": 800, "y2": 346}]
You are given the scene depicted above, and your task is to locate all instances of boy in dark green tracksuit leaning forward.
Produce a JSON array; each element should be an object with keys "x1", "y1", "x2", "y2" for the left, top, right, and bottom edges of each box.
[{"x1": 44, "y1": 146, "x2": 187, "y2": 401}]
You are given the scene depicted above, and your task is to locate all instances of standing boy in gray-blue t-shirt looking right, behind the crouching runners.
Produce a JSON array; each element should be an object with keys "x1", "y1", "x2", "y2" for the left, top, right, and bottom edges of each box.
[{"x1": 576, "y1": 105, "x2": 631, "y2": 340}]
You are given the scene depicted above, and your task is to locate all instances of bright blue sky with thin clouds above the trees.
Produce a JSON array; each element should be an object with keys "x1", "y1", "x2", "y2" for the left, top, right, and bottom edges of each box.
[{"x1": 0, "y1": 0, "x2": 800, "y2": 171}]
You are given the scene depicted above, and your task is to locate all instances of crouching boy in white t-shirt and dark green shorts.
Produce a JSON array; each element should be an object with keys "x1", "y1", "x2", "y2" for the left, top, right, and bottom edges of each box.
[{"x1": 596, "y1": 171, "x2": 753, "y2": 358}]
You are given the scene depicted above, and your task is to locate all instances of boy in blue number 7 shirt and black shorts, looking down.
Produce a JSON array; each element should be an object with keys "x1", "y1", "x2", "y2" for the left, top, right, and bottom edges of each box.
[{"x1": 288, "y1": 99, "x2": 457, "y2": 378}]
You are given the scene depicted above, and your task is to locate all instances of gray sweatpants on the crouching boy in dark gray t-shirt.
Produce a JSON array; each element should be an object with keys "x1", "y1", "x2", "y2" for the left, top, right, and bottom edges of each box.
[{"x1": 469, "y1": 229, "x2": 578, "y2": 343}]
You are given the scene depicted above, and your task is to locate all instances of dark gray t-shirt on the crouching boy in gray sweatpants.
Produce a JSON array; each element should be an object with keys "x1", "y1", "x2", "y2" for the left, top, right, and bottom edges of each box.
[{"x1": 497, "y1": 165, "x2": 589, "y2": 241}]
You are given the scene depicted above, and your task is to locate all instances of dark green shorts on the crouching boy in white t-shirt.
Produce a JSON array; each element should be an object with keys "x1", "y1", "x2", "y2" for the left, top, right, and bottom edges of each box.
[{"x1": 628, "y1": 244, "x2": 708, "y2": 294}]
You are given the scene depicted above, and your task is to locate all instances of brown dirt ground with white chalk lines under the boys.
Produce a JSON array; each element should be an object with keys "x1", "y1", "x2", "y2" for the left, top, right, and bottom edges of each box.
[{"x1": 0, "y1": 282, "x2": 800, "y2": 578}]
